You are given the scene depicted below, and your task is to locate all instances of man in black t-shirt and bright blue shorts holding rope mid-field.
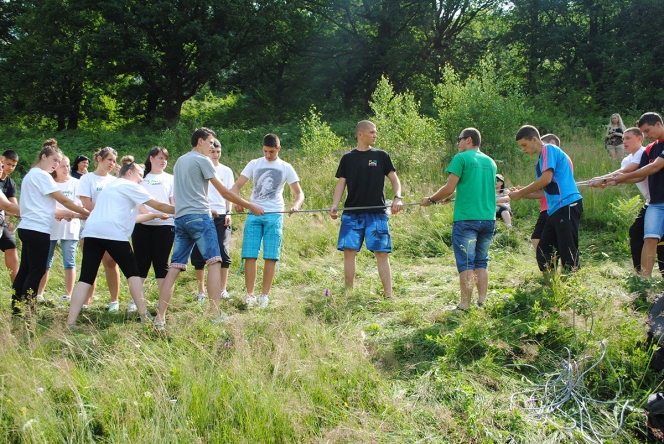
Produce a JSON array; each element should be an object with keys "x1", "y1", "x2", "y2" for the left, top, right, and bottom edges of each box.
[{"x1": 330, "y1": 120, "x2": 403, "y2": 298}]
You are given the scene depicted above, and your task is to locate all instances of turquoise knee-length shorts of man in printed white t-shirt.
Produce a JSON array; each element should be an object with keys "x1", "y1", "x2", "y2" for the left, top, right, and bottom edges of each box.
[{"x1": 242, "y1": 213, "x2": 284, "y2": 261}]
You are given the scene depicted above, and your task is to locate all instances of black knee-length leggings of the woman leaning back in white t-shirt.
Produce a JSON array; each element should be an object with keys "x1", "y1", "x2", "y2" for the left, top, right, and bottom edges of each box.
[{"x1": 78, "y1": 237, "x2": 139, "y2": 285}]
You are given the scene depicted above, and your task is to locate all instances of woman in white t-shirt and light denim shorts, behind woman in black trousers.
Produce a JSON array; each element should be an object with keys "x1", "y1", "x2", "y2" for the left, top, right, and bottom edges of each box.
[{"x1": 37, "y1": 156, "x2": 81, "y2": 302}]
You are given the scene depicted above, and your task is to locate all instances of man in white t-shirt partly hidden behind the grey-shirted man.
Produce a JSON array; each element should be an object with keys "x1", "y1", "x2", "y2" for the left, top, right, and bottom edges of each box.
[{"x1": 191, "y1": 139, "x2": 235, "y2": 302}]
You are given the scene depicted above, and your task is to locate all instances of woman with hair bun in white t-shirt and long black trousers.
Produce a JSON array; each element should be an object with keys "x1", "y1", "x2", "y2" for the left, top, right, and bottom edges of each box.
[{"x1": 12, "y1": 145, "x2": 89, "y2": 314}]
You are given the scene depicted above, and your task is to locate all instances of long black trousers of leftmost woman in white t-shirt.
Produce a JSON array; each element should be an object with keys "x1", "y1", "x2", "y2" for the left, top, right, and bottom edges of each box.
[{"x1": 12, "y1": 228, "x2": 51, "y2": 314}]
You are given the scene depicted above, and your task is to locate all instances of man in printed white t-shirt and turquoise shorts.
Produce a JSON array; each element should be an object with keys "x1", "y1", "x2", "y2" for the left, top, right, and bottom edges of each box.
[{"x1": 232, "y1": 134, "x2": 304, "y2": 308}]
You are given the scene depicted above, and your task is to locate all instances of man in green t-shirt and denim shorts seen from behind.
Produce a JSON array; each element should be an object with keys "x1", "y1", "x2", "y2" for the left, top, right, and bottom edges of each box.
[{"x1": 420, "y1": 128, "x2": 496, "y2": 311}]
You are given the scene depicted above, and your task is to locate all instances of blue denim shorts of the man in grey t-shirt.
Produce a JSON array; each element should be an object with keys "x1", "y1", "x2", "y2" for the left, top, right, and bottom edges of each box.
[{"x1": 169, "y1": 214, "x2": 221, "y2": 270}]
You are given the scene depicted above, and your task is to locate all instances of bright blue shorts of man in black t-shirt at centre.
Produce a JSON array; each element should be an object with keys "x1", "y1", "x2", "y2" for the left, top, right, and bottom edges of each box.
[{"x1": 337, "y1": 213, "x2": 392, "y2": 253}]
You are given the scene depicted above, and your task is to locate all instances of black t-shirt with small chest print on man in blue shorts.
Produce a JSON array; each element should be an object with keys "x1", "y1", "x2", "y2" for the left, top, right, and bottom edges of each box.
[{"x1": 336, "y1": 148, "x2": 396, "y2": 214}]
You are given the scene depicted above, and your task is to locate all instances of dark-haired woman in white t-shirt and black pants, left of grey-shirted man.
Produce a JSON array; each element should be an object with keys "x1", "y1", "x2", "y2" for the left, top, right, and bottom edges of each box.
[{"x1": 127, "y1": 146, "x2": 175, "y2": 304}]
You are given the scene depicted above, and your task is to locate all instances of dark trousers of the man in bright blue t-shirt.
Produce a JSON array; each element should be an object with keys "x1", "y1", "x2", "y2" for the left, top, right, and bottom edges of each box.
[{"x1": 537, "y1": 200, "x2": 583, "y2": 271}]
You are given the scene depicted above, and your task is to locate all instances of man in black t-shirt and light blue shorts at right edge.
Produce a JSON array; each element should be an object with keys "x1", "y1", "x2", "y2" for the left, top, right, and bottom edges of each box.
[{"x1": 613, "y1": 113, "x2": 664, "y2": 277}]
